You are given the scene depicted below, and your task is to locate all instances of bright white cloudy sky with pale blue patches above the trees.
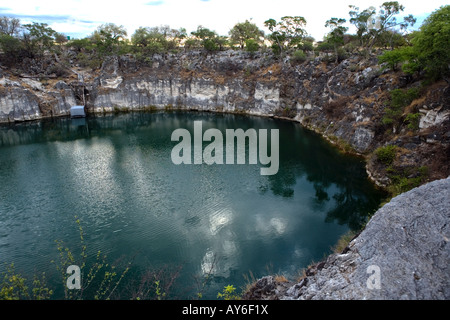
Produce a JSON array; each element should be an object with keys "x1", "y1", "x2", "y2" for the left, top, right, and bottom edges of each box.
[{"x1": 0, "y1": 0, "x2": 450, "y2": 41}]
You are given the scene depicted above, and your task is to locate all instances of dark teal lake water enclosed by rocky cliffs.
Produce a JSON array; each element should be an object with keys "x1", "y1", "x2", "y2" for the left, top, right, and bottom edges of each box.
[{"x1": 0, "y1": 112, "x2": 384, "y2": 299}]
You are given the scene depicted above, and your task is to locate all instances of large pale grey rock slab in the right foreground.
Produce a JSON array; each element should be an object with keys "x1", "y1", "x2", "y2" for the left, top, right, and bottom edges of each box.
[{"x1": 245, "y1": 178, "x2": 450, "y2": 300}]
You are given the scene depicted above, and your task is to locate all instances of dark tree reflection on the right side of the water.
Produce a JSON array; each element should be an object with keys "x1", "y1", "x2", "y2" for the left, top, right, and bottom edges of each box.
[{"x1": 269, "y1": 126, "x2": 382, "y2": 230}]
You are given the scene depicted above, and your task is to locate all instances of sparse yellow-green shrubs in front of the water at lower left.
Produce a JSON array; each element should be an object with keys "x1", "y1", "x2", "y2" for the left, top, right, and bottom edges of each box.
[{"x1": 0, "y1": 219, "x2": 185, "y2": 300}]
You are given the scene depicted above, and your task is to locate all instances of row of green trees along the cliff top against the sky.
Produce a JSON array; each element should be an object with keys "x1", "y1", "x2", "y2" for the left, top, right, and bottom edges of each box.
[{"x1": 0, "y1": 1, "x2": 444, "y2": 80}]
